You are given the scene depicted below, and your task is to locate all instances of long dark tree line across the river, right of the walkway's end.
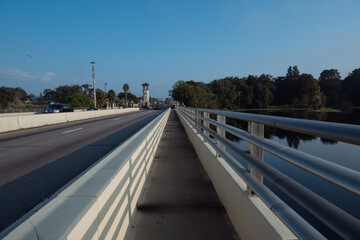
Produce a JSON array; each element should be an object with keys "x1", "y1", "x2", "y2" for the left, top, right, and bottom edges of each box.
[{"x1": 169, "y1": 66, "x2": 360, "y2": 110}]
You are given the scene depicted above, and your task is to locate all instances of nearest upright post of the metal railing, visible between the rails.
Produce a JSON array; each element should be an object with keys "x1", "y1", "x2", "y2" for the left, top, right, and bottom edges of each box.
[{"x1": 247, "y1": 122, "x2": 264, "y2": 194}]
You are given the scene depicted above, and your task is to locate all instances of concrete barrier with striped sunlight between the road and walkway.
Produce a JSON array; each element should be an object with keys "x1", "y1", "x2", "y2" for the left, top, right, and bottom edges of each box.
[{"x1": 4, "y1": 110, "x2": 170, "y2": 240}]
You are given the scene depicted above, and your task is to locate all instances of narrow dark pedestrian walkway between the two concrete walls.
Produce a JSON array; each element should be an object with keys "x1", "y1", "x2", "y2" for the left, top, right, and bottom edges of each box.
[{"x1": 129, "y1": 110, "x2": 239, "y2": 240}]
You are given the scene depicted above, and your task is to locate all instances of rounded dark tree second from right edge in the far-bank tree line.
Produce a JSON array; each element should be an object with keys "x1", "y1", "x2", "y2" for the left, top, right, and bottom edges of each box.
[{"x1": 319, "y1": 69, "x2": 342, "y2": 106}]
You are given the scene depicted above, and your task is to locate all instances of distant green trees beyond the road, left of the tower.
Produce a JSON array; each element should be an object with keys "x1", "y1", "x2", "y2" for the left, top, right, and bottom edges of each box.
[{"x1": 0, "y1": 83, "x2": 139, "y2": 108}]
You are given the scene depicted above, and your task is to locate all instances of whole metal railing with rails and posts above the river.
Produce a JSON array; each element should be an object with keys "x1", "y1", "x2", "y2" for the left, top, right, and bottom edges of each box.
[{"x1": 177, "y1": 107, "x2": 360, "y2": 239}]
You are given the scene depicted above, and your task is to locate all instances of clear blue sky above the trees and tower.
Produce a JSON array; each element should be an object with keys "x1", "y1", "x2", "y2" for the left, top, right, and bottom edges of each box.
[{"x1": 0, "y1": 0, "x2": 360, "y2": 98}]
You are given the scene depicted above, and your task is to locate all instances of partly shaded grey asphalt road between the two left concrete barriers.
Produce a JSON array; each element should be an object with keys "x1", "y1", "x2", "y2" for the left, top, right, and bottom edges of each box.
[{"x1": 0, "y1": 110, "x2": 162, "y2": 232}]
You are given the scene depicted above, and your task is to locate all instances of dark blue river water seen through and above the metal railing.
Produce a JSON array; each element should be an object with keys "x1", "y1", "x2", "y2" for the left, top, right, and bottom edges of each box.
[{"x1": 230, "y1": 109, "x2": 360, "y2": 239}]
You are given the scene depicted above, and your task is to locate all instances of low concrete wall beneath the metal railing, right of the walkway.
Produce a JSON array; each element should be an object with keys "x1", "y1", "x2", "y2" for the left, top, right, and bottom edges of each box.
[{"x1": 177, "y1": 109, "x2": 297, "y2": 240}]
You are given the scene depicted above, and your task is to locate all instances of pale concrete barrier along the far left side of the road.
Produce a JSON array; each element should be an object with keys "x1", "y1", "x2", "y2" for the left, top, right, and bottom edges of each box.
[{"x1": 0, "y1": 108, "x2": 139, "y2": 132}]
